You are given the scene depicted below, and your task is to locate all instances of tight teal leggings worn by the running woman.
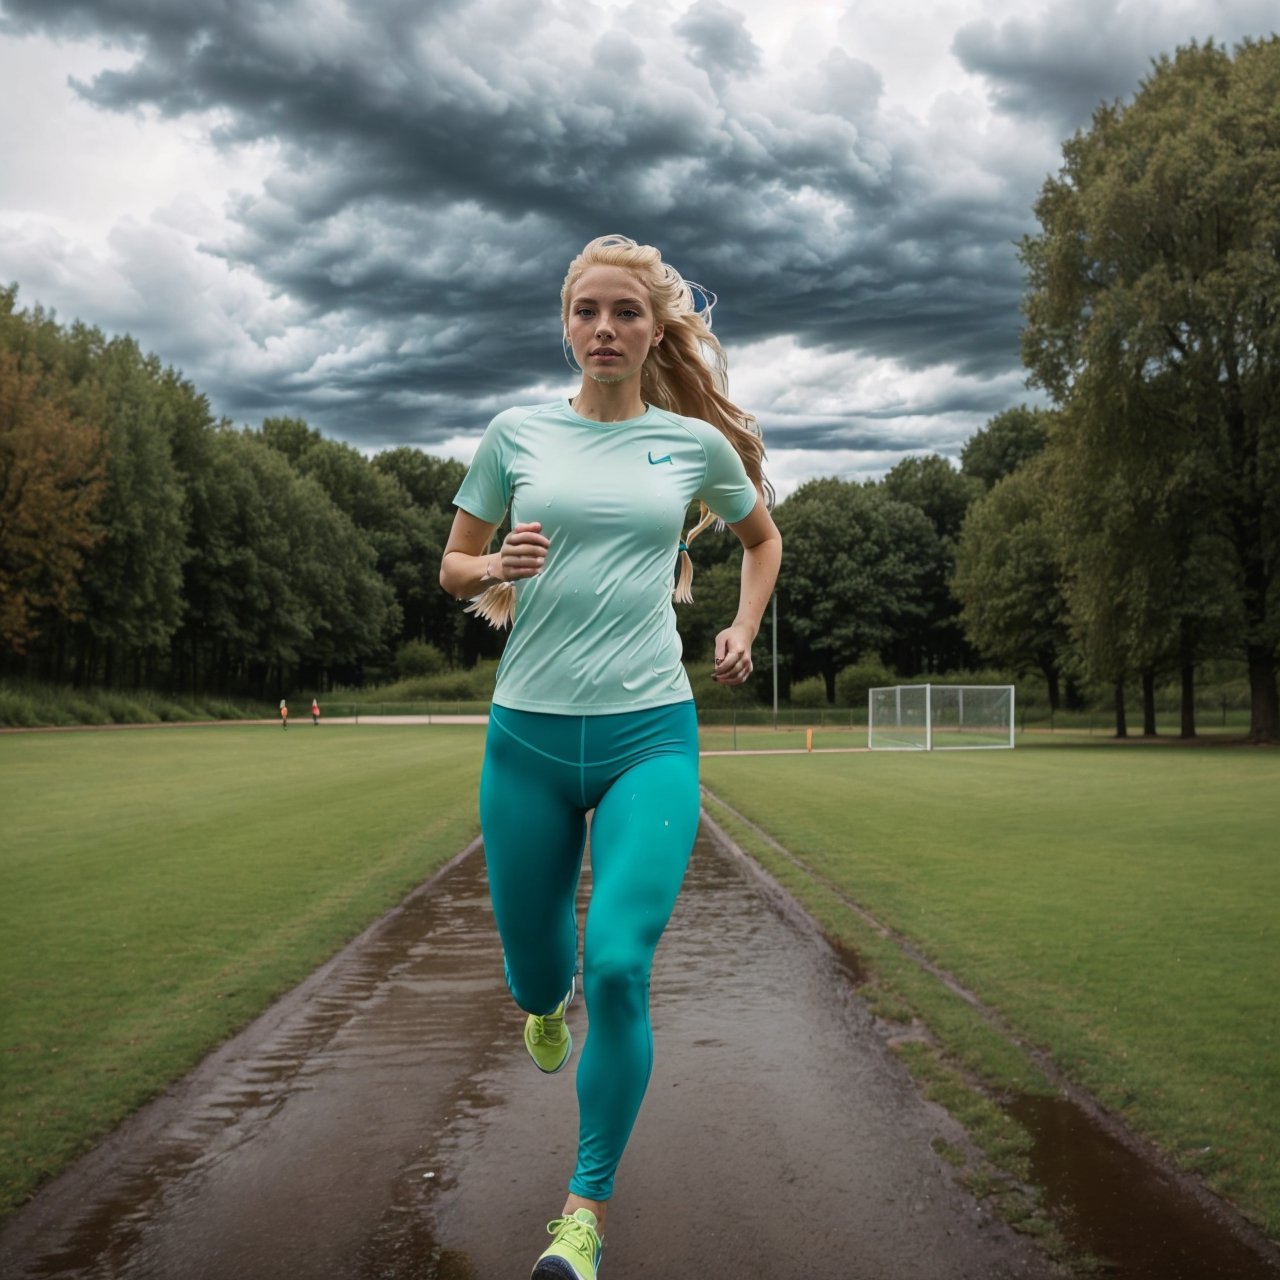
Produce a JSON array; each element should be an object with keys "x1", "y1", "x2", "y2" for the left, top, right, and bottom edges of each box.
[{"x1": 480, "y1": 701, "x2": 699, "y2": 1201}]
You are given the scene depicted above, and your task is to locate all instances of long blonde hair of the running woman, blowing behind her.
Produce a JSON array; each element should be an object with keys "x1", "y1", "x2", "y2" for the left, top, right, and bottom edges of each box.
[{"x1": 561, "y1": 236, "x2": 773, "y2": 604}]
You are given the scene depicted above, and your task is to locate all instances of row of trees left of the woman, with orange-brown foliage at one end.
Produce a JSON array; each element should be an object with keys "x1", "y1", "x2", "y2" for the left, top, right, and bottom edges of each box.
[{"x1": 0, "y1": 287, "x2": 493, "y2": 696}]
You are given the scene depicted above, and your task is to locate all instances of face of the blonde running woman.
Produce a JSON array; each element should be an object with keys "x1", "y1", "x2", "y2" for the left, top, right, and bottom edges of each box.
[{"x1": 564, "y1": 266, "x2": 662, "y2": 383}]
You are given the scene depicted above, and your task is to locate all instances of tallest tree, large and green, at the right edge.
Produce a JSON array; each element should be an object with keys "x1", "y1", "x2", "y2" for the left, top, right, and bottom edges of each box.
[{"x1": 1021, "y1": 37, "x2": 1280, "y2": 740}]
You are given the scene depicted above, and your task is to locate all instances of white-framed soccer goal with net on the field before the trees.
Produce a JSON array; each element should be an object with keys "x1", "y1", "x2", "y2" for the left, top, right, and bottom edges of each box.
[{"x1": 867, "y1": 685, "x2": 1014, "y2": 751}]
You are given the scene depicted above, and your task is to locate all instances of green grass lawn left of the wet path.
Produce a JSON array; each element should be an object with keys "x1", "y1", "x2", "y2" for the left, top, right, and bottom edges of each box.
[{"x1": 0, "y1": 717, "x2": 484, "y2": 1213}]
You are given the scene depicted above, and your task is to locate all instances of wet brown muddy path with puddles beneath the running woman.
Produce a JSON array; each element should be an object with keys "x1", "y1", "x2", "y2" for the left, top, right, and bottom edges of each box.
[{"x1": 0, "y1": 819, "x2": 1280, "y2": 1280}]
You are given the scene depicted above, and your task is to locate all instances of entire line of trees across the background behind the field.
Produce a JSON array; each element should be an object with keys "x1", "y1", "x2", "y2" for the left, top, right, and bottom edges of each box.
[{"x1": 0, "y1": 40, "x2": 1280, "y2": 740}]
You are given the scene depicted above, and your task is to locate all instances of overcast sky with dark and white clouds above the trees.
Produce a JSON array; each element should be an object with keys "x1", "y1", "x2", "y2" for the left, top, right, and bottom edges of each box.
[{"x1": 0, "y1": 0, "x2": 1277, "y2": 493}]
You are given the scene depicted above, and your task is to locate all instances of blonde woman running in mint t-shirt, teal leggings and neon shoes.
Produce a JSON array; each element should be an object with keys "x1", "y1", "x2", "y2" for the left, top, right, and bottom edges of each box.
[{"x1": 440, "y1": 236, "x2": 782, "y2": 1280}]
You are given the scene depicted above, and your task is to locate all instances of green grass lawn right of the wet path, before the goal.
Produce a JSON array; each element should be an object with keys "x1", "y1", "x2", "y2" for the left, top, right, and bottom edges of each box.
[{"x1": 703, "y1": 742, "x2": 1280, "y2": 1235}]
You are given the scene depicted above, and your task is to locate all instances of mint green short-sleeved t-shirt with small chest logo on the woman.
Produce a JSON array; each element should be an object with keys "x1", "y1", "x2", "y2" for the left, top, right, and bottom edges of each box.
[{"x1": 453, "y1": 401, "x2": 756, "y2": 716}]
